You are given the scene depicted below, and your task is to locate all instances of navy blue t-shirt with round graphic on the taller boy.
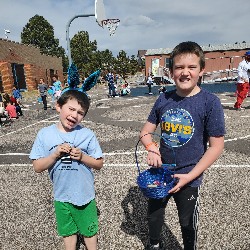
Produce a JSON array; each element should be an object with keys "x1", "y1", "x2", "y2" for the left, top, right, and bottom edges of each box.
[{"x1": 148, "y1": 89, "x2": 225, "y2": 186}]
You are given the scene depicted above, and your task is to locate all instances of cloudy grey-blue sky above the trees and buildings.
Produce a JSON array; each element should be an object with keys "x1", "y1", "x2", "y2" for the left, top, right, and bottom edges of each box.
[{"x1": 0, "y1": 0, "x2": 250, "y2": 56}]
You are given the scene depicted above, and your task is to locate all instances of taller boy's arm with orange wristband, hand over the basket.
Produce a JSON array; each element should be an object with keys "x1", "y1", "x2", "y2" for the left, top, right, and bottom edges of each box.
[{"x1": 140, "y1": 122, "x2": 162, "y2": 167}]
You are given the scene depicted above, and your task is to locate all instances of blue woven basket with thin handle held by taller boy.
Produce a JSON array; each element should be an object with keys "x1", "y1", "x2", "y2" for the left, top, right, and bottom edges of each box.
[{"x1": 135, "y1": 133, "x2": 176, "y2": 199}]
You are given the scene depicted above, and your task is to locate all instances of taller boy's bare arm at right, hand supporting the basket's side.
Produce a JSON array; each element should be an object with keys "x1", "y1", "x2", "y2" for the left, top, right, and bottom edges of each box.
[{"x1": 169, "y1": 136, "x2": 224, "y2": 193}]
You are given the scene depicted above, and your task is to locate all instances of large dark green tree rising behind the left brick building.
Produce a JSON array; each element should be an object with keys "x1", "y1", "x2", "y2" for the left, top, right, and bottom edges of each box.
[{"x1": 21, "y1": 15, "x2": 68, "y2": 70}]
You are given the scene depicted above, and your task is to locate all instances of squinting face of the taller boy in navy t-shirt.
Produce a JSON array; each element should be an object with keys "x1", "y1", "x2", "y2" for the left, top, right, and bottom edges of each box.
[{"x1": 171, "y1": 54, "x2": 204, "y2": 96}]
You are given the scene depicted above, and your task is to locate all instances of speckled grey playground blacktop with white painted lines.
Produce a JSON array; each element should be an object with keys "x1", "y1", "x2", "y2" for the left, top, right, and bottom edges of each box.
[{"x1": 0, "y1": 85, "x2": 250, "y2": 250}]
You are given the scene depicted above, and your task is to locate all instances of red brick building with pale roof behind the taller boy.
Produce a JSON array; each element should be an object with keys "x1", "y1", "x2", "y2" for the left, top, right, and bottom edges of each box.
[{"x1": 145, "y1": 42, "x2": 250, "y2": 82}]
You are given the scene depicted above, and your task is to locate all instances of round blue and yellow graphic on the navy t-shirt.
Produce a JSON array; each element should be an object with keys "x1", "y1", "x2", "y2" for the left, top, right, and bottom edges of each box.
[{"x1": 161, "y1": 108, "x2": 194, "y2": 147}]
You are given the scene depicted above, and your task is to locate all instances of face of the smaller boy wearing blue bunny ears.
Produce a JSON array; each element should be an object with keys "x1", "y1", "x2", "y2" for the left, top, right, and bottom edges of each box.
[{"x1": 56, "y1": 99, "x2": 85, "y2": 132}]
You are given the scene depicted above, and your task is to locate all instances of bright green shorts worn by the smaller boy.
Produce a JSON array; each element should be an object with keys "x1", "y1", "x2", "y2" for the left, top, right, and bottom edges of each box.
[{"x1": 54, "y1": 200, "x2": 98, "y2": 237}]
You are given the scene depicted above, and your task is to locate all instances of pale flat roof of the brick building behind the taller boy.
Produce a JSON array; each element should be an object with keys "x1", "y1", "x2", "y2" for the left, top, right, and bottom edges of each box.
[{"x1": 145, "y1": 43, "x2": 250, "y2": 56}]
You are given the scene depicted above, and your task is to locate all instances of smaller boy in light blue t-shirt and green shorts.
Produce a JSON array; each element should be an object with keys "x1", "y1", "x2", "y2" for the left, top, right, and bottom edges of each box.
[{"x1": 30, "y1": 90, "x2": 103, "y2": 250}]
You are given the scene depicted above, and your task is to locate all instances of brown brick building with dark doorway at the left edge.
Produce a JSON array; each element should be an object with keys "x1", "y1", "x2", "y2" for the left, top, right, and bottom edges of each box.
[{"x1": 0, "y1": 38, "x2": 63, "y2": 92}]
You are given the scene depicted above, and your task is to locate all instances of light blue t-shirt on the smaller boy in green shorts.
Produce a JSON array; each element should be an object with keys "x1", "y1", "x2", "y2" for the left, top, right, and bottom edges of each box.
[{"x1": 29, "y1": 124, "x2": 103, "y2": 206}]
